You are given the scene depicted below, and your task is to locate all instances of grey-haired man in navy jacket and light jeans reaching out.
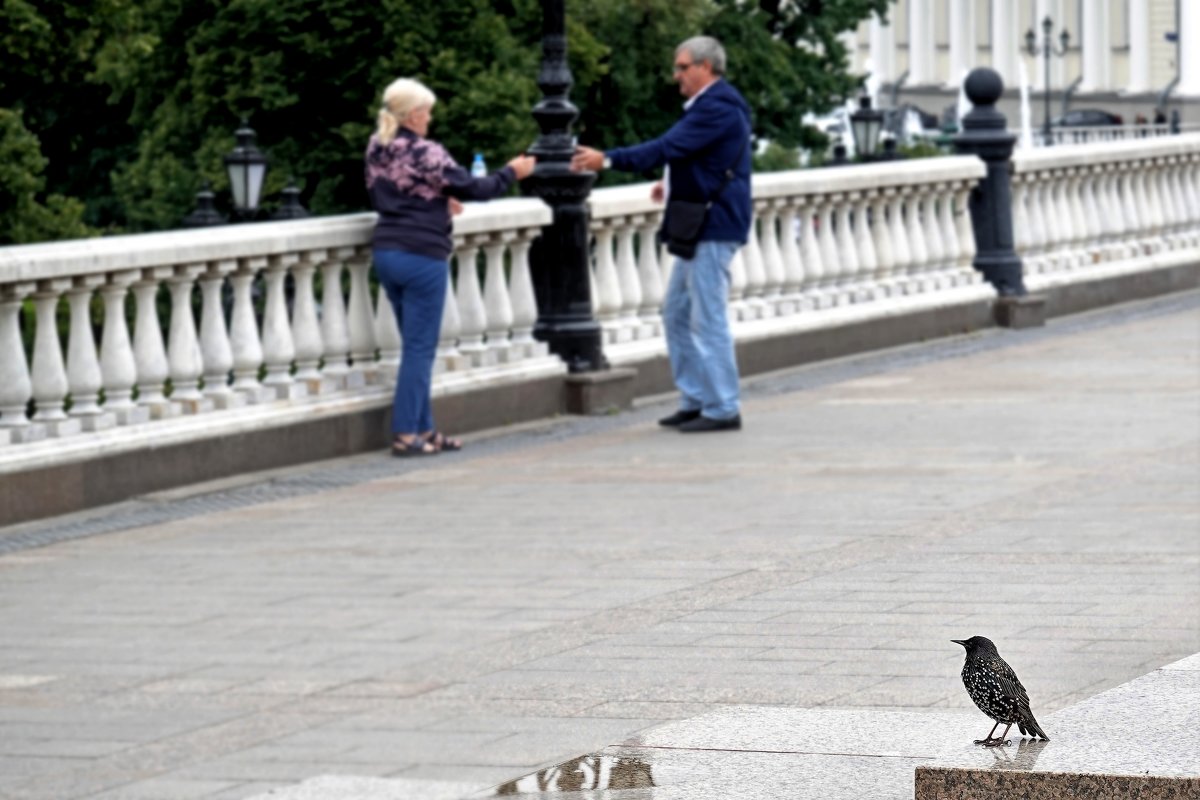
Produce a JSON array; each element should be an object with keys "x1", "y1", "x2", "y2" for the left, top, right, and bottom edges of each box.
[{"x1": 571, "y1": 36, "x2": 751, "y2": 433}]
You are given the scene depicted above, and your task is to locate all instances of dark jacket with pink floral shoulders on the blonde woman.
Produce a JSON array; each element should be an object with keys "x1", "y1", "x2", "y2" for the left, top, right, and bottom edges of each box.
[{"x1": 366, "y1": 128, "x2": 516, "y2": 260}]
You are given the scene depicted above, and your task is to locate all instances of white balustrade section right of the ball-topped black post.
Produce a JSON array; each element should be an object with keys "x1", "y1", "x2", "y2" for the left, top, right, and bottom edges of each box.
[{"x1": 1013, "y1": 133, "x2": 1200, "y2": 276}]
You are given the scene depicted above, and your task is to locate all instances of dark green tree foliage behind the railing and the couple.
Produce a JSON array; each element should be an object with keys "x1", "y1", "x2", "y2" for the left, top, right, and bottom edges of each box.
[{"x1": 0, "y1": 0, "x2": 887, "y2": 242}]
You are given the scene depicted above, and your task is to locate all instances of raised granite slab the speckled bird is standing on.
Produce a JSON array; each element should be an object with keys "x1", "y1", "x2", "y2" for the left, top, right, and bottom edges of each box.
[{"x1": 916, "y1": 657, "x2": 1200, "y2": 800}]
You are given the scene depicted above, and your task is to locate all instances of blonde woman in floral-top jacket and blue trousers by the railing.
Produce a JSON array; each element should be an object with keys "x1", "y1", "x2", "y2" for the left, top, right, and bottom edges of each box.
[{"x1": 366, "y1": 78, "x2": 534, "y2": 456}]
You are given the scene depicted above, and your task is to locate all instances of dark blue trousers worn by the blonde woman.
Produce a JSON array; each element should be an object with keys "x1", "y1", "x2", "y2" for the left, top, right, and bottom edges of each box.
[{"x1": 374, "y1": 249, "x2": 450, "y2": 435}]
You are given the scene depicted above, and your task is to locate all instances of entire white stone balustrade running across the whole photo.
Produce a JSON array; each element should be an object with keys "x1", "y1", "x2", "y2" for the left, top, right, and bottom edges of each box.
[{"x1": 7, "y1": 134, "x2": 1200, "y2": 453}]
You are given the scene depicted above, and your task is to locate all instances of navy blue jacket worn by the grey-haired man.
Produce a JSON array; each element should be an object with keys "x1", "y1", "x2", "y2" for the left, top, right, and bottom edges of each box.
[{"x1": 605, "y1": 79, "x2": 751, "y2": 243}]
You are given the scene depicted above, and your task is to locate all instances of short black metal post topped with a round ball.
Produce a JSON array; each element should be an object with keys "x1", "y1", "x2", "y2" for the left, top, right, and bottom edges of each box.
[{"x1": 954, "y1": 67, "x2": 1025, "y2": 296}]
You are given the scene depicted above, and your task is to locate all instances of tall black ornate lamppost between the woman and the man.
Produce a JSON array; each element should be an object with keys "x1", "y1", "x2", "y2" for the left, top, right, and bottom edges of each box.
[{"x1": 524, "y1": 0, "x2": 608, "y2": 372}]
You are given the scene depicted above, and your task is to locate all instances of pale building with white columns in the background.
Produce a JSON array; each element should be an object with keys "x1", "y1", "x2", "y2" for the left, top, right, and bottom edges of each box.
[{"x1": 848, "y1": 0, "x2": 1200, "y2": 125}]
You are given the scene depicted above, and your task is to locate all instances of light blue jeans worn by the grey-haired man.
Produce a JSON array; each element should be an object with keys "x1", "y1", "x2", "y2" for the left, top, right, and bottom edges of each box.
[{"x1": 662, "y1": 241, "x2": 740, "y2": 420}]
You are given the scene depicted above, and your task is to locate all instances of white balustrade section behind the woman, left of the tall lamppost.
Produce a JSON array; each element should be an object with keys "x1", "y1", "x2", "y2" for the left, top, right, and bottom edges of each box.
[{"x1": 0, "y1": 199, "x2": 551, "y2": 444}]
